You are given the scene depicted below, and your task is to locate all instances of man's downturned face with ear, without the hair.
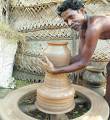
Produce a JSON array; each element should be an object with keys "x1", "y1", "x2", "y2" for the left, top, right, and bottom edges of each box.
[{"x1": 61, "y1": 9, "x2": 84, "y2": 31}]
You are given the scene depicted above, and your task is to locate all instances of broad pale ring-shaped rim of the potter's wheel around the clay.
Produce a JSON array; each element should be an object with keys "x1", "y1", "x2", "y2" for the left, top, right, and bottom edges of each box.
[{"x1": 0, "y1": 84, "x2": 109, "y2": 120}]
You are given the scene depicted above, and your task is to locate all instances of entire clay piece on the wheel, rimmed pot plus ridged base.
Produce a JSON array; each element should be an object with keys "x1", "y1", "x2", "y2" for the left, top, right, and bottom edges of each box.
[{"x1": 36, "y1": 43, "x2": 75, "y2": 114}]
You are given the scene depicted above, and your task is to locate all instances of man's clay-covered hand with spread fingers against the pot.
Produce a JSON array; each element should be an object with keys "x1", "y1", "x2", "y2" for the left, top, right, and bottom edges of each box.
[{"x1": 38, "y1": 56, "x2": 59, "y2": 74}]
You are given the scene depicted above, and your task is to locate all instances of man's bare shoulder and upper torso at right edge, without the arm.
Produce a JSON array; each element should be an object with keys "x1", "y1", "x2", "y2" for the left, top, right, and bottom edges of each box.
[{"x1": 83, "y1": 16, "x2": 110, "y2": 40}]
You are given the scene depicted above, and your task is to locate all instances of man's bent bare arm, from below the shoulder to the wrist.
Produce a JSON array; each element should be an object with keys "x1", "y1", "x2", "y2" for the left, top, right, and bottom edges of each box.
[{"x1": 56, "y1": 27, "x2": 100, "y2": 73}]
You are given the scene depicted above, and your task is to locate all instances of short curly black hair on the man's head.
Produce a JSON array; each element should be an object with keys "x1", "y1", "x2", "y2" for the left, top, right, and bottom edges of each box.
[{"x1": 57, "y1": 0, "x2": 84, "y2": 16}]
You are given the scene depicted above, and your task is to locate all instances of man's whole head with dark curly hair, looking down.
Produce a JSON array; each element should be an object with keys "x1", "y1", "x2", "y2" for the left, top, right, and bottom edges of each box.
[{"x1": 57, "y1": 0, "x2": 85, "y2": 30}]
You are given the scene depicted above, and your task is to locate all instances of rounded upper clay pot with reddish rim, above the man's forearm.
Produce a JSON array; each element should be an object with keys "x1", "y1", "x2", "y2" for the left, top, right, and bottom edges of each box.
[{"x1": 44, "y1": 42, "x2": 71, "y2": 66}]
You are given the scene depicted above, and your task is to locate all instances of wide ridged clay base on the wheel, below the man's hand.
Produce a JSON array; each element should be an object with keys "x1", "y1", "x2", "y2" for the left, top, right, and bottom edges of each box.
[{"x1": 36, "y1": 73, "x2": 75, "y2": 114}]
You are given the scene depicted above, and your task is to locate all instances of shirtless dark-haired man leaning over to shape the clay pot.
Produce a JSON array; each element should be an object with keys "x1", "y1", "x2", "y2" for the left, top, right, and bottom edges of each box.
[{"x1": 40, "y1": 0, "x2": 110, "y2": 105}]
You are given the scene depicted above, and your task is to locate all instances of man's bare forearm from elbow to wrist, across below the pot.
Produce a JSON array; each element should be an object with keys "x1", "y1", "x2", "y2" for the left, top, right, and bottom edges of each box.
[{"x1": 57, "y1": 61, "x2": 87, "y2": 73}]
